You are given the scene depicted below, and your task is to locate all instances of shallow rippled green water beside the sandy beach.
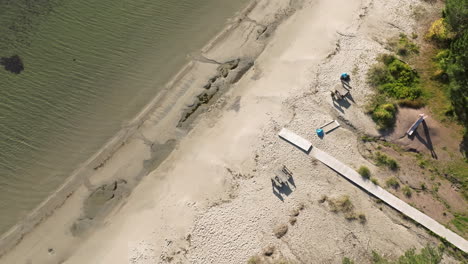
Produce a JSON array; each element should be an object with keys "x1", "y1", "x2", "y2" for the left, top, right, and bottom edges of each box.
[{"x1": 0, "y1": 0, "x2": 247, "y2": 233}]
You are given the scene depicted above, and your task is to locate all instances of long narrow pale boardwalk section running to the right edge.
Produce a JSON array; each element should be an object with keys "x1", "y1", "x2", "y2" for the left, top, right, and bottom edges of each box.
[{"x1": 310, "y1": 147, "x2": 468, "y2": 252}]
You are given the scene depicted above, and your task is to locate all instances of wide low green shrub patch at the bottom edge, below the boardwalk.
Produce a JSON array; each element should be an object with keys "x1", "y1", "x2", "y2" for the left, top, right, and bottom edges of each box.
[{"x1": 372, "y1": 246, "x2": 443, "y2": 264}]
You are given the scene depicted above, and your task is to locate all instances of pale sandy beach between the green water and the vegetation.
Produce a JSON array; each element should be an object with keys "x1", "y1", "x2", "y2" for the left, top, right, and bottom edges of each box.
[{"x1": 0, "y1": 0, "x2": 464, "y2": 264}]
